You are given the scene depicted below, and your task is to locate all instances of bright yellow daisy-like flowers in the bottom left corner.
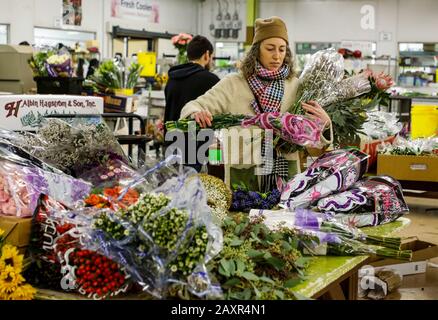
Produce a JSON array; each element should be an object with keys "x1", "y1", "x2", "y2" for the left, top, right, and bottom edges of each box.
[{"x1": 0, "y1": 229, "x2": 36, "y2": 300}]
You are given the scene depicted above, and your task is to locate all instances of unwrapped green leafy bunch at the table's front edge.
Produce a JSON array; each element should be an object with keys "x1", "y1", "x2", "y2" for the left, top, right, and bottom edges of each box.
[{"x1": 198, "y1": 214, "x2": 308, "y2": 300}]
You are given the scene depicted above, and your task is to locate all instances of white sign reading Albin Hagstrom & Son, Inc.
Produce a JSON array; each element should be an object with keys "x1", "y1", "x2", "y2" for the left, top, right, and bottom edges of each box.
[{"x1": 0, "y1": 95, "x2": 103, "y2": 131}]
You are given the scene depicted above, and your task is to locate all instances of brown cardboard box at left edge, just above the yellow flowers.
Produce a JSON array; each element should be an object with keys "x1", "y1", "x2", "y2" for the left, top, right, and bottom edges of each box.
[{"x1": 0, "y1": 217, "x2": 32, "y2": 251}]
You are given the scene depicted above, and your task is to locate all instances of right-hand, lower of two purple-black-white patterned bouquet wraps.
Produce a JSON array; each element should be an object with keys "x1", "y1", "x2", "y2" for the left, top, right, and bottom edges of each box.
[{"x1": 316, "y1": 176, "x2": 409, "y2": 227}]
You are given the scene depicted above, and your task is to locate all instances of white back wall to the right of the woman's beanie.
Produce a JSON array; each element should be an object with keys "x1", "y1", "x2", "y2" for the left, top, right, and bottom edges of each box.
[{"x1": 259, "y1": 0, "x2": 438, "y2": 57}]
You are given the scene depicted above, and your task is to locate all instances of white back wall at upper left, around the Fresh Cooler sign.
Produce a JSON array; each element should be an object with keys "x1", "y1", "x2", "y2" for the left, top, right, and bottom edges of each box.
[{"x1": 0, "y1": 0, "x2": 199, "y2": 57}]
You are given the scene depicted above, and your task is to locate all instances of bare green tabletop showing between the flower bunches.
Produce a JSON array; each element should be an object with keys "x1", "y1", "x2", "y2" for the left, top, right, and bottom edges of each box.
[{"x1": 292, "y1": 217, "x2": 410, "y2": 297}]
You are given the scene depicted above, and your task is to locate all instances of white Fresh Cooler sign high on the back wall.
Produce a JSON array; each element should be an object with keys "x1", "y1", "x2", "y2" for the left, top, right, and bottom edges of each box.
[{"x1": 111, "y1": 0, "x2": 159, "y2": 23}]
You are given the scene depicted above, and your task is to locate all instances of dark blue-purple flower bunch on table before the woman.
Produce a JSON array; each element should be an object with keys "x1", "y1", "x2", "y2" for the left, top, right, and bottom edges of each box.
[{"x1": 231, "y1": 186, "x2": 281, "y2": 212}]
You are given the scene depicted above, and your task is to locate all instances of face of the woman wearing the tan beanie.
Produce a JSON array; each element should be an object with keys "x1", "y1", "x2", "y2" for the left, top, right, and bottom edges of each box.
[{"x1": 259, "y1": 38, "x2": 287, "y2": 71}]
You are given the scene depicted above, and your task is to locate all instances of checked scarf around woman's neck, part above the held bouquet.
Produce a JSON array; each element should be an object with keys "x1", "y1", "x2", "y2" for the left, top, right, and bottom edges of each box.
[{"x1": 247, "y1": 61, "x2": 290, "y2": 114}]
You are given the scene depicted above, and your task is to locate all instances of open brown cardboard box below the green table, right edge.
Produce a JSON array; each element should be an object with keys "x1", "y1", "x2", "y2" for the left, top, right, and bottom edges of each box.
[{"x1": 370, "y1": 238, "x2": 438, "y2": 267}]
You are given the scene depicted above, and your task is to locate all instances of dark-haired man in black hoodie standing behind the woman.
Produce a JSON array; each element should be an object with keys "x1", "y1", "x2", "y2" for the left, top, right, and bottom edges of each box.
[{"x1": 164, "y1": 35, "x2": 219, "y2": 171}]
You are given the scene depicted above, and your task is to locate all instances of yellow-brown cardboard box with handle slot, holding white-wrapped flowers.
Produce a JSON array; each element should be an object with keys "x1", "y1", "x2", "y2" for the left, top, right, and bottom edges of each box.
[{"x1": 377, "y1": 154, "x2": 438, "y2": 182}]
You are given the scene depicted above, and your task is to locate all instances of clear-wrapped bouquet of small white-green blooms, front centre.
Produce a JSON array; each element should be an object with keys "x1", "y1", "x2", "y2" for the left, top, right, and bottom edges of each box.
[{"x1": 76, "y1": 159, "x2": 222, "y2": 298}]
